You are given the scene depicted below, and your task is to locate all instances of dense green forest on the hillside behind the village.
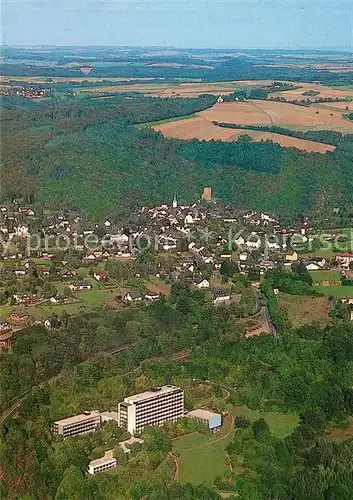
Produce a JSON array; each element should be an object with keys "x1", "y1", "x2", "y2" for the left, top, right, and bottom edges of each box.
[{"x1": 1, "y1": 95, "x2": 353, "y2": 225}]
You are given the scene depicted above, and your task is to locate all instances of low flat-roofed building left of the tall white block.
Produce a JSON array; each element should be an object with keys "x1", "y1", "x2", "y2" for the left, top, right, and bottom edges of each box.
[{"x1": 52, "y1": 411, "x2": 101, "y2": 437}]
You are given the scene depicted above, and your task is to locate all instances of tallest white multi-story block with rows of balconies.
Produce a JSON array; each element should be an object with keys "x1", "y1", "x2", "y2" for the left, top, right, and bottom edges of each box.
[{"x1": 119, "y1": 385, "x2": 184, "y2": 434}]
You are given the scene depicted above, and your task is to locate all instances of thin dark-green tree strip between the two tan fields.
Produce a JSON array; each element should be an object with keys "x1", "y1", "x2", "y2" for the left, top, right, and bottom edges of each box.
[{"x1": 212, "y1": 121, "x2": 353, "y2": 146}]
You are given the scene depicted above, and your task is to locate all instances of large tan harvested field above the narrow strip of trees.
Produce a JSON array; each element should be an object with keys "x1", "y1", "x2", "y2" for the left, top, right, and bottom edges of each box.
[{"x1": 199, "y1": 100, "x2": 353, "y2": 132}]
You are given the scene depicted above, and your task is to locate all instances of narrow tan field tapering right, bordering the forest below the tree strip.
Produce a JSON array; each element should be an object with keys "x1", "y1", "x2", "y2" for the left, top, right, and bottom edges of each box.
[{"x1": 153, "y1": 115, "x2": 336, "y2": 153}]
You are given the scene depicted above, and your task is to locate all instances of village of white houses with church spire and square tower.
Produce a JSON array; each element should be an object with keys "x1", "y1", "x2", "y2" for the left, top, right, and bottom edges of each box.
[{"x1": 0, "y1": 187, "x2": 353, "y2": 350}]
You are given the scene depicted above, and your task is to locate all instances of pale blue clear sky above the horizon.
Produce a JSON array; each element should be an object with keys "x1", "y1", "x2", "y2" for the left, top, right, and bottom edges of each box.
[{"x1": 1, "y1": 0, "x2": 353, "y2": 51}]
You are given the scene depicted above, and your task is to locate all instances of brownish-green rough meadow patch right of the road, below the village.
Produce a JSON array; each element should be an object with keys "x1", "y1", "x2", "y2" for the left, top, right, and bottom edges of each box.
[{"x1": 279, "y1": 293, "x2": 331, "y2": 328}]
